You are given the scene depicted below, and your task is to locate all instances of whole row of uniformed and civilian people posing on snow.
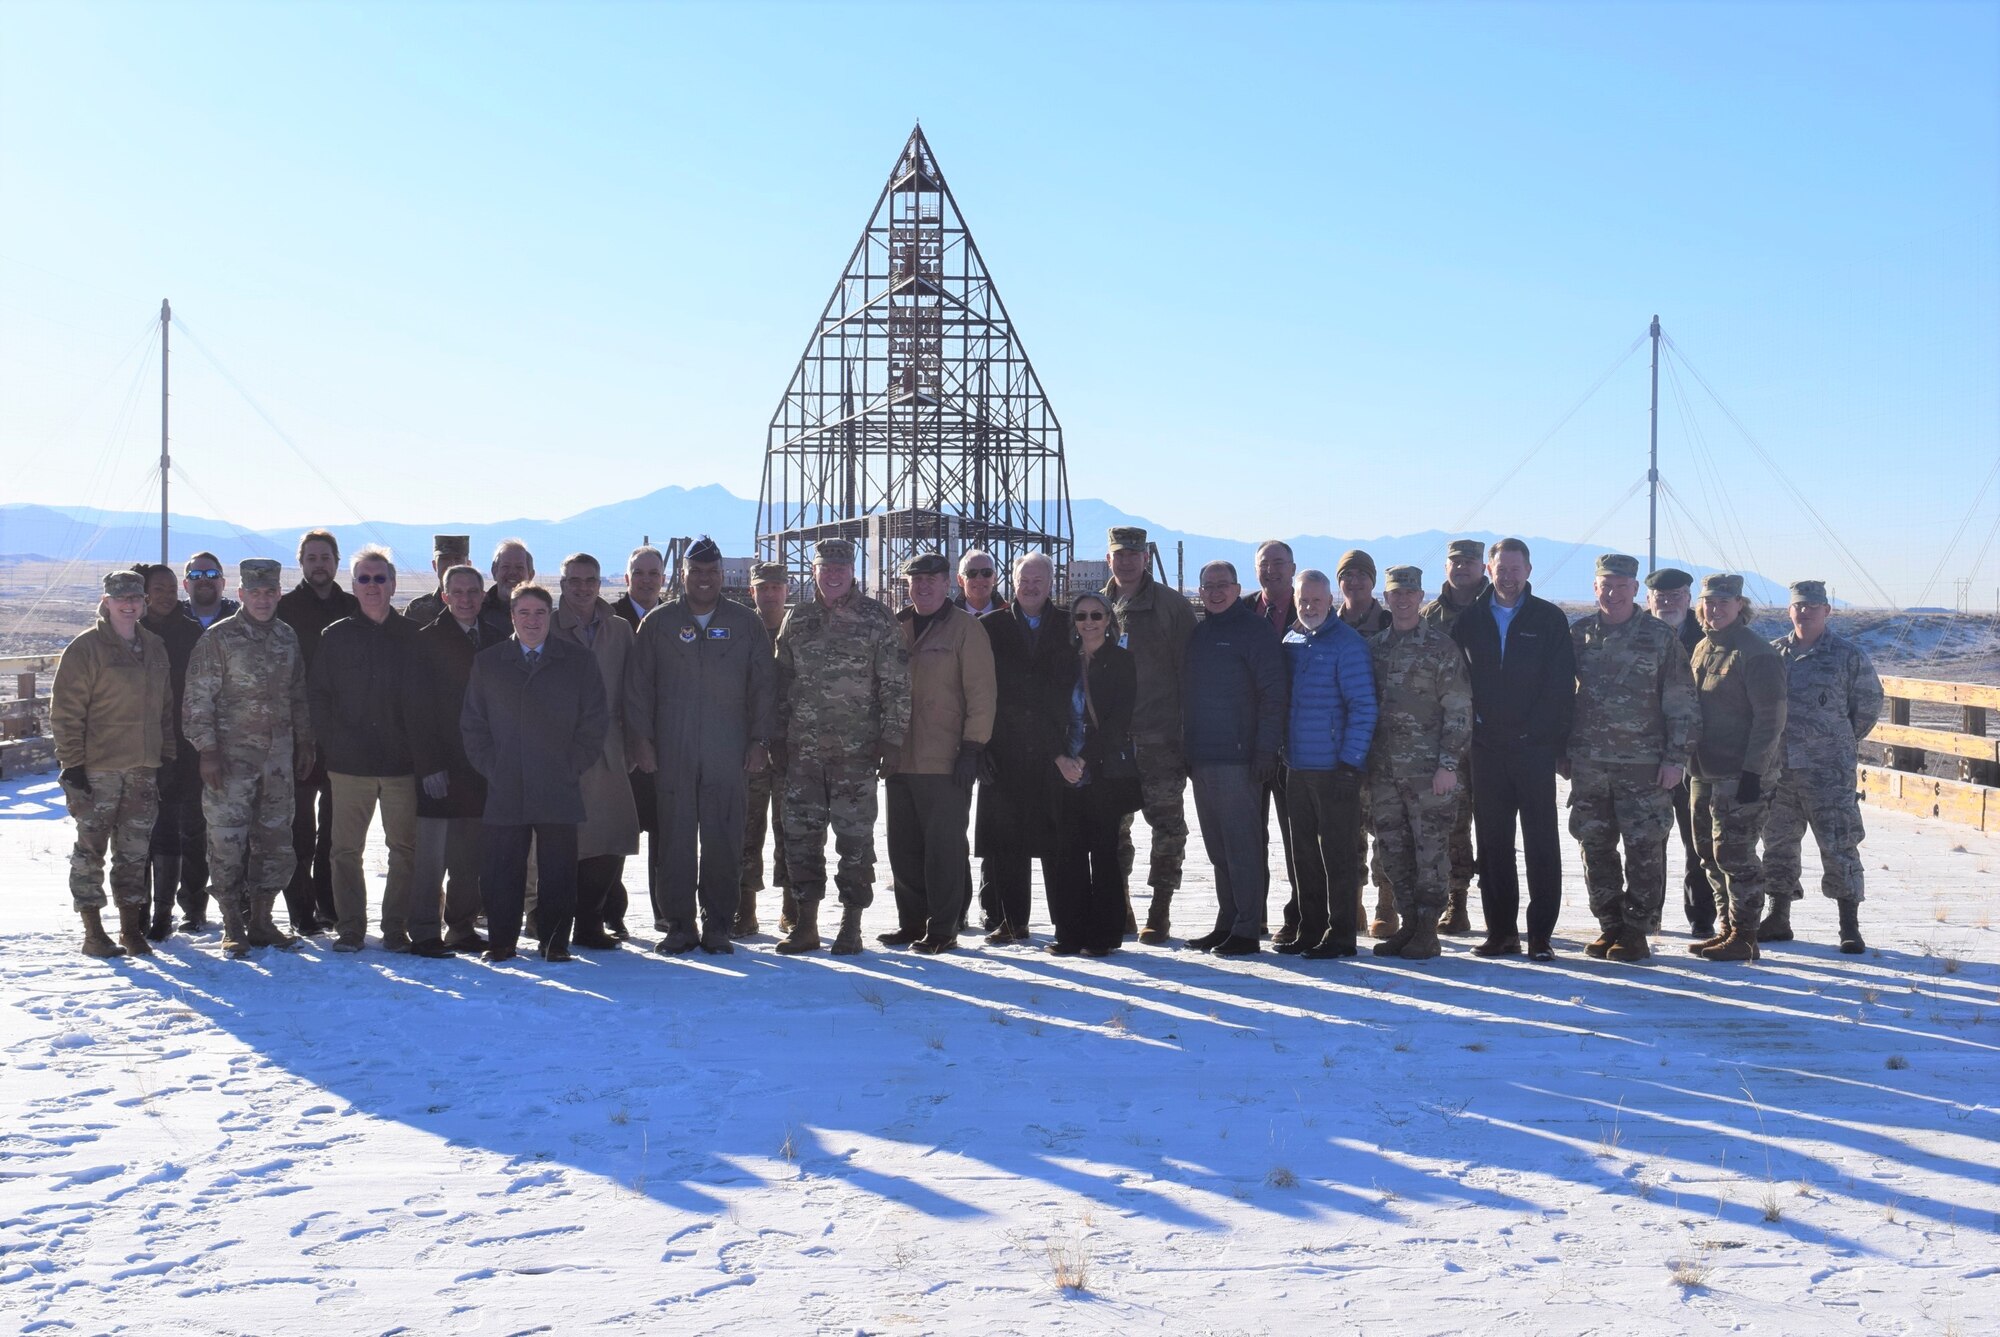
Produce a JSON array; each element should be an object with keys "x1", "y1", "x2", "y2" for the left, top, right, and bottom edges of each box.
[{"x1": 52, "y1": 526, "x2": 1882, "y2": 961}]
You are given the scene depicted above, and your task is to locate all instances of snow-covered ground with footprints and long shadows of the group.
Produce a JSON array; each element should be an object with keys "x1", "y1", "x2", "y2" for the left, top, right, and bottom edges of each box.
[{"x1": 0, "y1": 777, "x2": 2000, "y2": 1335}]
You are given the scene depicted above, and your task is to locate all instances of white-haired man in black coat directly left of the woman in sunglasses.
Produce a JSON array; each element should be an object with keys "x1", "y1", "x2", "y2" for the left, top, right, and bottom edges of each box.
[{"x1": 976, "y1": 552, "x2": 1072, "y2": 947}]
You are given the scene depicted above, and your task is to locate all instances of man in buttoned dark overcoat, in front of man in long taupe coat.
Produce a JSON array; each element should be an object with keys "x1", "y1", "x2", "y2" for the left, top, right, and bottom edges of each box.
[{"x1": 458, "y1": 580, "x2": 612, "y2": 961}]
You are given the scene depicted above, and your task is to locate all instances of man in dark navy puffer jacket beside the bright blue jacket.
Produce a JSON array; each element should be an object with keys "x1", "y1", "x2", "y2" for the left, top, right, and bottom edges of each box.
[{"x1": 1180, "y1": 562, "x2": 1288, "y2": 957}]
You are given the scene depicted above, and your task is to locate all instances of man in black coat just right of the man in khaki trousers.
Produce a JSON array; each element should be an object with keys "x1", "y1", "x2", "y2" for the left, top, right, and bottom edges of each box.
[{"x1": 402, "y1": 566, "x2": 492, "y2": 957}]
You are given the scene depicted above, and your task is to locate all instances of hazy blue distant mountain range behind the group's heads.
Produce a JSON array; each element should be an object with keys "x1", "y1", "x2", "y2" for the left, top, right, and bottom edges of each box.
[{"x1": 0, "y1": 484, "x2": 1786, "y2": 606}]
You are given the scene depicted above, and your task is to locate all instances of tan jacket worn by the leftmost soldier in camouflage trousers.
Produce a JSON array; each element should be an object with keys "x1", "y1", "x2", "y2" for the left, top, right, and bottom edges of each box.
[{"x1": 48, "y1": 614, "x2": 174, "y2": 771}]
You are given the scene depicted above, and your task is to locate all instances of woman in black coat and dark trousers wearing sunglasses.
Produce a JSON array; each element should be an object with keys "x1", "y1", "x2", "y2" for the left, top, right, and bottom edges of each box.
[{"x1": 1048, "y1": 592, "x2": 1140, "y2": 957}]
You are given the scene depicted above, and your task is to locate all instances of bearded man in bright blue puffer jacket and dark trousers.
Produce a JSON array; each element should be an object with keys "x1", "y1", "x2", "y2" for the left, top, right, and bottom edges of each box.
[{"x1": 1278, "y1": 570, "x2": 1376, "y2": 959}]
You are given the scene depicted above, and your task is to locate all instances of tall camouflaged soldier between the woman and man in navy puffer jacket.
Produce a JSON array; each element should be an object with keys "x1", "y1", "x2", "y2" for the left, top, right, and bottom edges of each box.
[{"x1": 1102, "y1": 524, "x2": 1194, "y2": 947}]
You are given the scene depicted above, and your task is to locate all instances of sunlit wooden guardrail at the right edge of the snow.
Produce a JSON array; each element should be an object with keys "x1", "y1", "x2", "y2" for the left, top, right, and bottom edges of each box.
[{"x1": 1858, "y1": 679, "x2": 2000, "y2": 831}]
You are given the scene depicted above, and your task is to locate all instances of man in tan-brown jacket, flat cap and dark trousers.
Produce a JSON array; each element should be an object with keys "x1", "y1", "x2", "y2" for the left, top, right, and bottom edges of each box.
[{"x1": 876, "y1": 552, "x2": 994, "y2": 955}]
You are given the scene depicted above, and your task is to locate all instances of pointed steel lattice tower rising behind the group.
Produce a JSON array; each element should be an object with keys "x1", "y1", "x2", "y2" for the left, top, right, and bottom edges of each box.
[{"x1": 758, "y1": 126, "x2": 1072, "y2": 594}]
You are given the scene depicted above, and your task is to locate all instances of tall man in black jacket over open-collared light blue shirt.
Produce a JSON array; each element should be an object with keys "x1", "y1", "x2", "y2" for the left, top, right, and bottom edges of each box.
[{"x1": 1452, "y1": 538, "x2": 1576, "y2": 961}]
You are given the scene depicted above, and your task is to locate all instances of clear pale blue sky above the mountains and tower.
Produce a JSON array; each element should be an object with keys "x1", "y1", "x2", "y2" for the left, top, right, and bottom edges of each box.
[{"x1": 0, "y1": 2, "x2": 2000, "y2": 604}]
